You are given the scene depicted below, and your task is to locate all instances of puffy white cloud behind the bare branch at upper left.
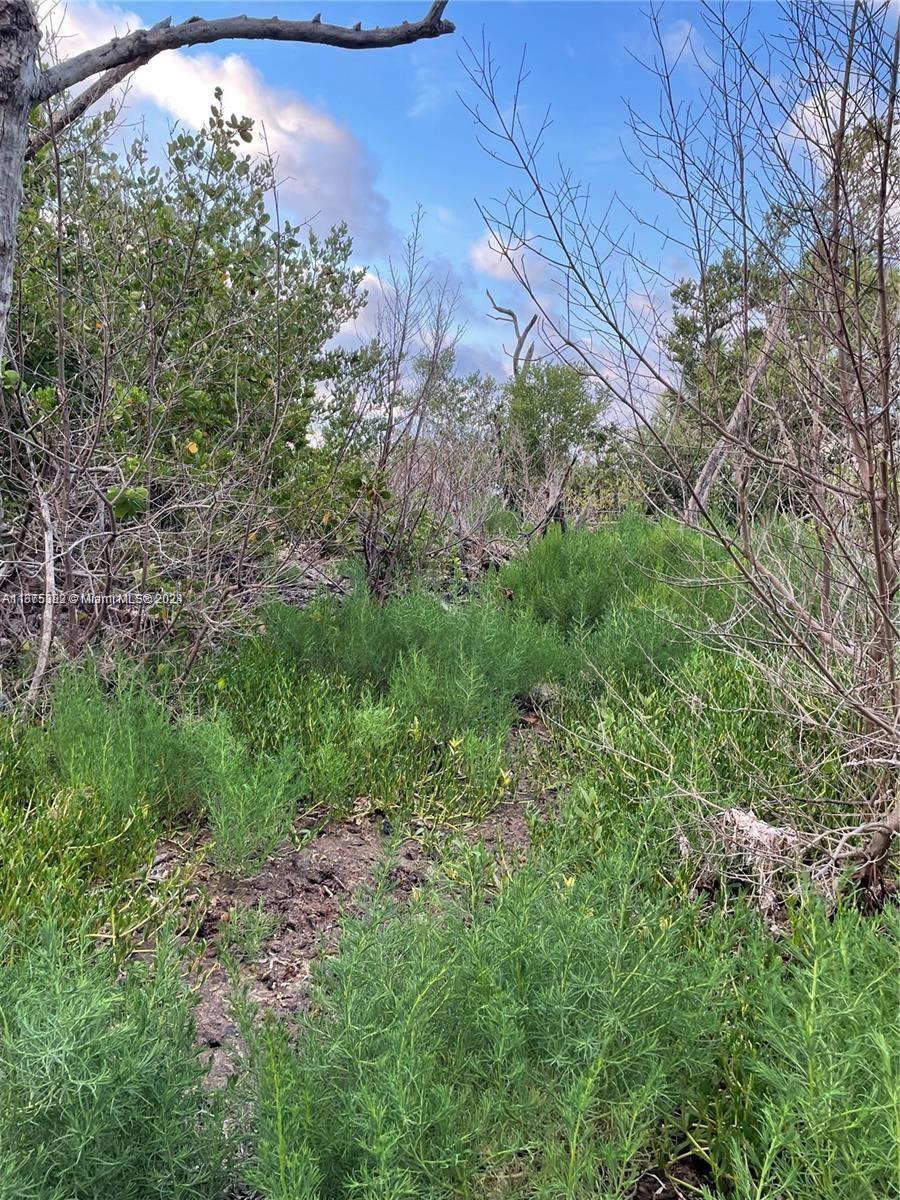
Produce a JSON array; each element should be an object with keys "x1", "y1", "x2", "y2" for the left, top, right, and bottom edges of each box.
[{"x1": 44, "y1": 0, "x2": 391, "y2": 251}]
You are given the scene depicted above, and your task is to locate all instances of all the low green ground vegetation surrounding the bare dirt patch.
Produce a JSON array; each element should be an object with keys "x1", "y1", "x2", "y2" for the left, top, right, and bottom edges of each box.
[{"x1": 0, "y1": 518, "x2": 900, "y2": 1200}]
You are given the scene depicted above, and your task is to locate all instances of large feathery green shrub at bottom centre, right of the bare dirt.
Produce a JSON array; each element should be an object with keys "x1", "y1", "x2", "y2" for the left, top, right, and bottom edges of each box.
[{"x1": 248, "y1": 802, "x2": 725, "y2": 1200}]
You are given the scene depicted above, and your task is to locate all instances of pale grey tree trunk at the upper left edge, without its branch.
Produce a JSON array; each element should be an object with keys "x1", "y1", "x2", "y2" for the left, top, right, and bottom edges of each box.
[{"x1": 0, "y1": 0, "x2": 41, "y2": 359}]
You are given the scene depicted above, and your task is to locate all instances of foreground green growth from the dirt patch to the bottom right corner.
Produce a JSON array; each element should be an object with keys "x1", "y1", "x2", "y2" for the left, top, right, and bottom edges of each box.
[{"x1": 241, "y1": 788, "x2": 900, "y2": 1200}]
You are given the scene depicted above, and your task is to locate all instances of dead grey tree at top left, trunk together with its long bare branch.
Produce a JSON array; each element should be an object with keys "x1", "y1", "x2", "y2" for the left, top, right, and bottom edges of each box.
[{"x1": 0, "y1": 0, "x2": 454, "y2": 355}]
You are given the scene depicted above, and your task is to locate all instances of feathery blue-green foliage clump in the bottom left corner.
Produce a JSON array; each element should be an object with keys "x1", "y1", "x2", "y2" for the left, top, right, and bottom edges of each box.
[{"x1": 0, "y1": 925, "x2": 229, "y2": 1200}]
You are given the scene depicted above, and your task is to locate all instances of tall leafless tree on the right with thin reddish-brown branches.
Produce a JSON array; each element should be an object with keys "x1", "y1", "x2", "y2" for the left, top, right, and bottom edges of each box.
[{"x1": 472, "y1": 0, "x2": 900, "y2": 882}]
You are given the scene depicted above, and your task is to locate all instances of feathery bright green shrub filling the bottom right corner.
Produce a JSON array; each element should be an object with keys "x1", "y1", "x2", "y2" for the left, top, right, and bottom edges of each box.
[{"x1": 724, "y1": 902, "x2": 900, "y2": 1200}]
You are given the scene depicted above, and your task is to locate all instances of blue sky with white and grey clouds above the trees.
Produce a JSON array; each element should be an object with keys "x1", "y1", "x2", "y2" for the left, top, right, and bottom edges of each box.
[{"x1": 44, "y1": 0, "x2": 776, "y2": 374}]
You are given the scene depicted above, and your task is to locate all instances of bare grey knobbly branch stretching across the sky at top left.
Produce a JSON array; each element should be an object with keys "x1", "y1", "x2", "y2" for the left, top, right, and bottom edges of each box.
[{"x1": 34, "y1": 0, "x2": 454, "y2": 104}]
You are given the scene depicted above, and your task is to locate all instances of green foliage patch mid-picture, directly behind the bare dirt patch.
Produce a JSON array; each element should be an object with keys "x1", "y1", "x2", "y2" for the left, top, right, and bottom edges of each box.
[{"x1": 205, "y1": 588, "x2": 570, "y2": 818}]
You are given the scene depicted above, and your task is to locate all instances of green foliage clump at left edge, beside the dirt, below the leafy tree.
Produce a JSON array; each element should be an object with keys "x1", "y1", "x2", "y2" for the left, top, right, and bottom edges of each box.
[{"x1": 0, "y1": 667, "x2": 200, "y2": 940}]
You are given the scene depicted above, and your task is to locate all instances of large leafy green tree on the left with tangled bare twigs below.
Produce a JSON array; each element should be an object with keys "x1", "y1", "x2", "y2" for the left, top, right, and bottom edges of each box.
[{"x1": 0, "y1": 92, "x2": 365, "y2": 682}]
